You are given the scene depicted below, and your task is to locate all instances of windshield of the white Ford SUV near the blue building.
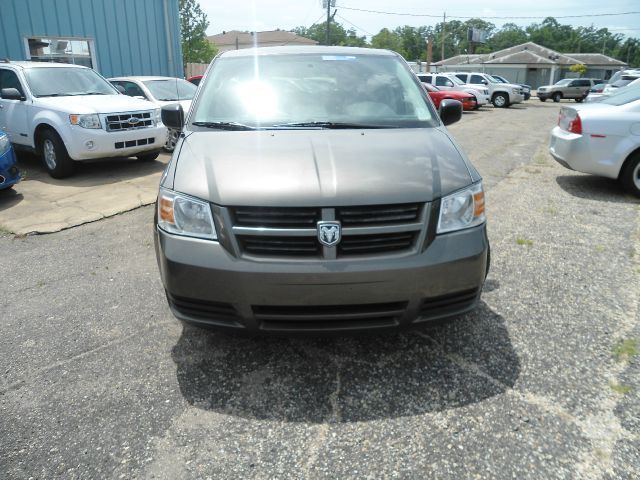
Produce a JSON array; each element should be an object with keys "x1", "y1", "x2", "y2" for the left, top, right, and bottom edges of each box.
[{"x1": 24, "y1": 67, "x2": 119, "y2": 97}]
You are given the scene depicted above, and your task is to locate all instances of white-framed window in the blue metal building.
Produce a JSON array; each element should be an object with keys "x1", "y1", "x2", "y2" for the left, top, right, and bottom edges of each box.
[{"x1": 25, "y1": 37, "x2": 96, "y2": 68}]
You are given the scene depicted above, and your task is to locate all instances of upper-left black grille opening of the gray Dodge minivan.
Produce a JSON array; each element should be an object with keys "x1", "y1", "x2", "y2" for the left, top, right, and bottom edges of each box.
[{"x1": 231, "y1": 207, "x2": 320, "y2": 228}]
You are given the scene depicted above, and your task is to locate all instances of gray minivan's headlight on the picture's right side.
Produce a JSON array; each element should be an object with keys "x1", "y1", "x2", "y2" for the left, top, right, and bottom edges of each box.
[{"x1": 438, "y1": 182, "x2": 486, "y2": 233}]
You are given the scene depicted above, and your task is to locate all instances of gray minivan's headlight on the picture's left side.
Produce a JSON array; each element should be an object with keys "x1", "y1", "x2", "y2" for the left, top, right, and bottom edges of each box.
[{"x1": 158, "y1": 188, "x2": 218, "y2": 240}]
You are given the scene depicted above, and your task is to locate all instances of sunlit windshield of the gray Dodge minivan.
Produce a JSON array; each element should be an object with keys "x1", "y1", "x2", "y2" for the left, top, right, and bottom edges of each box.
[{"x1": 190, "y1": 53, "x2": 439, "y2": 129}]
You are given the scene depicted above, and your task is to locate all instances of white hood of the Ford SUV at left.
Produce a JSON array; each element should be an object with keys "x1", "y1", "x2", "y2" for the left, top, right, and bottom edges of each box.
[{"x1": 38, "y1": 95, "x2": 158, "y2": 114}]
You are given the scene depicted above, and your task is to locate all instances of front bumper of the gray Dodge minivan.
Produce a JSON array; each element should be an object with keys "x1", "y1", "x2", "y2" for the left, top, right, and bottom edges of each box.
[{"x1": 155, "y1": 225, "x2": 489, "y2": 333}]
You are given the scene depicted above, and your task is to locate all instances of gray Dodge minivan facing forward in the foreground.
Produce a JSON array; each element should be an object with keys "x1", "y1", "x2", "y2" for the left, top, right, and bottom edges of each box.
[{"x1": 155, "y1": 46, "x2": 489, "y2": 333}]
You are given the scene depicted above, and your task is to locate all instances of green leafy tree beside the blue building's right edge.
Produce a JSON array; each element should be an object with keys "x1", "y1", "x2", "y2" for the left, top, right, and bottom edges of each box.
[{"x1": 180, "y1": 0, "x2": 218, "y2": 66}]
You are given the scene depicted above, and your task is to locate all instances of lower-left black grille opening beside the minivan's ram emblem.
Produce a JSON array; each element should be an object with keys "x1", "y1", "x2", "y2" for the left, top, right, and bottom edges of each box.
[{"x1": 237, "y1": 235, "x2": 321, "y2": 257}]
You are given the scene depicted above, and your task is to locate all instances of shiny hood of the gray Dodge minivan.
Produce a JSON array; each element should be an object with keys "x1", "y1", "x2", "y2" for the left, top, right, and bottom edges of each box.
[{"x1": 173, "y1": 128, "x2": 471, "y2": 207}]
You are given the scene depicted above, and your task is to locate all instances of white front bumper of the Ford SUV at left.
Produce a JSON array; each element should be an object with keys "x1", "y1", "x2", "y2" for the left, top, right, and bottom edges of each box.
[{"x1": 63, "y1": 125, "x2": 167, "y2": 160}]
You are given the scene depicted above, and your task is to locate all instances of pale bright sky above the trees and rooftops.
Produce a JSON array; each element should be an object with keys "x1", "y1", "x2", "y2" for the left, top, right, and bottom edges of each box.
[{"x1": 199, "y1": 0, "x2": 640, "y2": 40}]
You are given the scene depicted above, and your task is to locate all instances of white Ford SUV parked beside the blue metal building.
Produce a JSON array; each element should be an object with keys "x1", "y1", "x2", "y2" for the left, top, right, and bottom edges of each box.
[{"x1": 0, "y1": 61, "x2": 167, "y2": 178}]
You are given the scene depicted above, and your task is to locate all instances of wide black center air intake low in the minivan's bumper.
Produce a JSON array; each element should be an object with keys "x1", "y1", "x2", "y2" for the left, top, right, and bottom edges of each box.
[{"x1": 252, "y1": 302, "x2": 407, "y2": 331}]
